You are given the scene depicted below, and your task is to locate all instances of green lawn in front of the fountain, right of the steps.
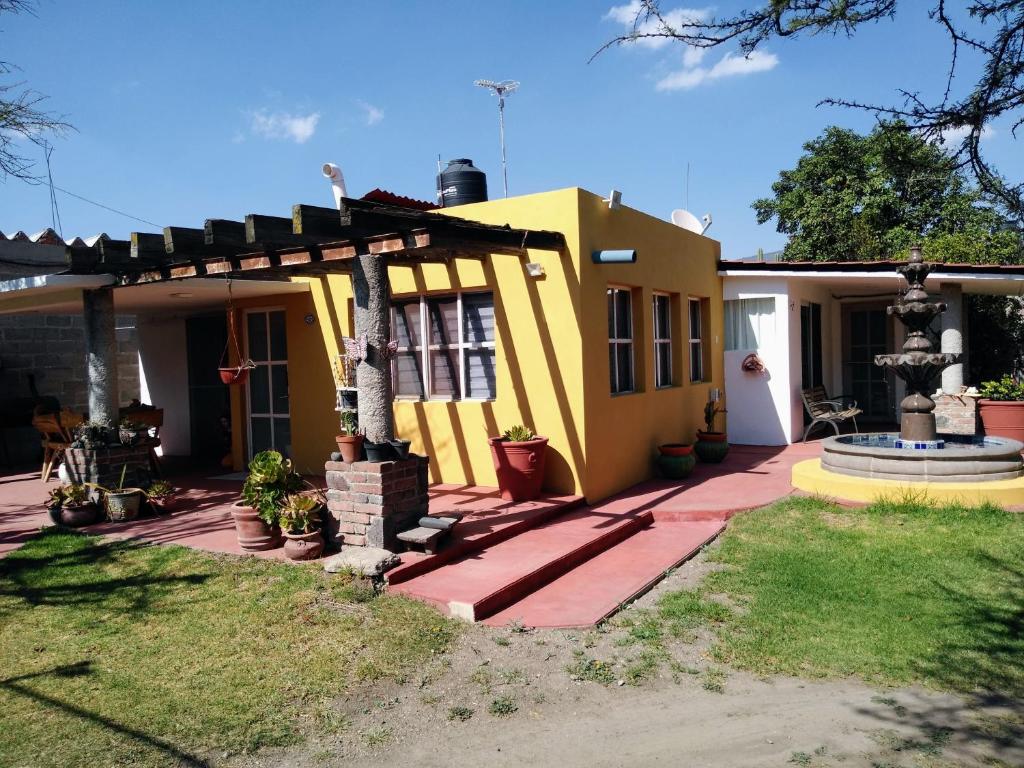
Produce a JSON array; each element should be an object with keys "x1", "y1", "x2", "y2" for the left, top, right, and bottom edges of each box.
[{"x1": 630, "y1": 499, "x2": 1024, "y2": 696}]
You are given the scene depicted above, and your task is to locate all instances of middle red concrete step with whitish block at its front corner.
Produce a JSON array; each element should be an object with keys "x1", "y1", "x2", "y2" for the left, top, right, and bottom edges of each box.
[{"x1": 389, "y1": 508, "x2": 654, "y2": 622}]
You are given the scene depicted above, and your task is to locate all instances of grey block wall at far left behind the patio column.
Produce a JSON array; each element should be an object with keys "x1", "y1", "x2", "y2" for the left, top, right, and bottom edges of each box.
[{"x1": 0, "y1": 314, "x2": 139, "y2": 412}]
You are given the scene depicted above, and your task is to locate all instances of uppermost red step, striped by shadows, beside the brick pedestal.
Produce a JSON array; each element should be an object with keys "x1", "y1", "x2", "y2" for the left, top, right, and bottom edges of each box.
[{"x1": 385, "y1": 496, "x2": 584, "y2": 585}]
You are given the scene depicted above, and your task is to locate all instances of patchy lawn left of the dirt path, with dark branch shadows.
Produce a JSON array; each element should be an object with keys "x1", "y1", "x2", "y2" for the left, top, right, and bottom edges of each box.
[{"x1": 0, "y1": 530, "x2": 457, "y2": 767}]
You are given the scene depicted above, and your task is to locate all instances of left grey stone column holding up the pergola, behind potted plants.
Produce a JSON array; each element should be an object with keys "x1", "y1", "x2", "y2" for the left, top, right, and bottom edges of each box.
[{"x1": 82, "y1": 288, "x2": 120, "y2": 427}]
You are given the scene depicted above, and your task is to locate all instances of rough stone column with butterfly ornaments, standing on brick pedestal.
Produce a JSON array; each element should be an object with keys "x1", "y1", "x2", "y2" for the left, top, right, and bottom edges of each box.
[{"x1": 352, "y1": 254, "x2": 394, "y2": 442}]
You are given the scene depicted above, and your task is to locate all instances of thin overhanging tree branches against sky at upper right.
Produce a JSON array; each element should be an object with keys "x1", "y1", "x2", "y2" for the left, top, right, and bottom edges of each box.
[{"x1": 595, "y1": 0, "x2": 1024, "y2": 220}]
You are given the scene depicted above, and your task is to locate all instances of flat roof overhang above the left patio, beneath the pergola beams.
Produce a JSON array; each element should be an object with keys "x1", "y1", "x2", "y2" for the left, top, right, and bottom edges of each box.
[{"x1": 0, "y1": 274, "x2": 309, "y2": 314}]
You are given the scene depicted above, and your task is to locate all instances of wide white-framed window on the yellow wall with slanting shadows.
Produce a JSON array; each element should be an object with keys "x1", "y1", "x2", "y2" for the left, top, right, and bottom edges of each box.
[{"x1": 392, "y1": 293, "x2": 497, "y2": 400}]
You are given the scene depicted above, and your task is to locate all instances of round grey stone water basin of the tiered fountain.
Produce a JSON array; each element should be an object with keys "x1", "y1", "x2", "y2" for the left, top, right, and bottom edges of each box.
[{"x1": 821, "y1": 432, "x2": 1024, "y2": 482}]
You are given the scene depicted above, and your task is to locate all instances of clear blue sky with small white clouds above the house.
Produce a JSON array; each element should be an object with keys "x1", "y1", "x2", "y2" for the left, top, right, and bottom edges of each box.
[{"x1": 0, "y1": 0, "x2": 1024, "y2": 257}]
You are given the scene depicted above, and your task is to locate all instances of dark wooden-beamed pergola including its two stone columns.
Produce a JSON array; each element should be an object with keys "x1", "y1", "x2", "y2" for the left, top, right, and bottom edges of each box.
[{"x1": 12, "y1": 199, "x2": 565, "y2": 441}]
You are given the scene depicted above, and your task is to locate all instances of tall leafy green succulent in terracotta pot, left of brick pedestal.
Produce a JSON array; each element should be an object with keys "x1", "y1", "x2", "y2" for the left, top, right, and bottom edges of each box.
[{"x1": 231, "y1": 451, "x2": 302, "y2": 551}]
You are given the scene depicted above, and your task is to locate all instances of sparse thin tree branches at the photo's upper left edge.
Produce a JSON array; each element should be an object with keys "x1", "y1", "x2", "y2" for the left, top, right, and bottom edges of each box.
[{"x1": 0, "y1": 0, "x2": 71, "y2": 181}]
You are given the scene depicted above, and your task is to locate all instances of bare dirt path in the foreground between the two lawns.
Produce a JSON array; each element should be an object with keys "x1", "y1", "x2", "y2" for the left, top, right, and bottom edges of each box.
[{"x1": 235, "y1": 557, "x2": 1024, "y2": 768}]
